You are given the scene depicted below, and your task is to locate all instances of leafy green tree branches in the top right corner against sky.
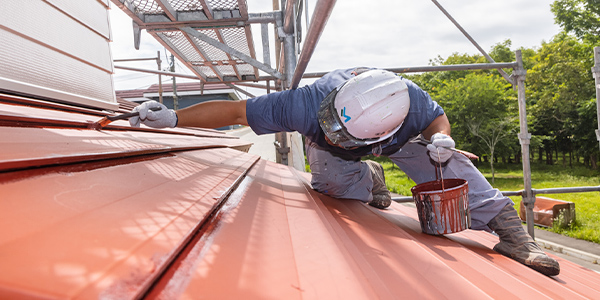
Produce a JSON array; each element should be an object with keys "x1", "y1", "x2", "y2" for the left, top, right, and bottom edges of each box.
[{"x1": 552, "y1": 0, "x2": 600, "y2": 43}]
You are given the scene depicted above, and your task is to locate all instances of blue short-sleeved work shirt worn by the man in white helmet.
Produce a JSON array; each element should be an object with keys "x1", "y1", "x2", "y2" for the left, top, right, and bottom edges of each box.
[{"x1": 246, "y1": 69, "x2": 444, "y2": 160}]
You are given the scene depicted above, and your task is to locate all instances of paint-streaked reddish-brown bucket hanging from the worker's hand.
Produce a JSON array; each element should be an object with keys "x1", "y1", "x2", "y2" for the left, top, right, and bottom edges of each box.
[{"x1": 411, "y1": 179, "x2": 471, "y2": 235}]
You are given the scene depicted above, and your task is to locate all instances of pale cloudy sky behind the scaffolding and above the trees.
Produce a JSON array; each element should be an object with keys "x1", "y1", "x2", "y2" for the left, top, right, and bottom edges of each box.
[{"x1": 109, "y1": 0, "x2": 560, "y2": 97}]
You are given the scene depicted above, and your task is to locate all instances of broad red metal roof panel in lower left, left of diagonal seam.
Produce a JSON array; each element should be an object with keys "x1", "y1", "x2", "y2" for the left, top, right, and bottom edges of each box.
[{"x1": 0, "y1": 149, "x2": 258, "y2": 299}]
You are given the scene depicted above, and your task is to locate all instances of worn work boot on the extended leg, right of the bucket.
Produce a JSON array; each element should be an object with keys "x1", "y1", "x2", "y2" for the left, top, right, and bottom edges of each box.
[{"x1": 488, "y1": 204, "x2": 560, "y2": 276}]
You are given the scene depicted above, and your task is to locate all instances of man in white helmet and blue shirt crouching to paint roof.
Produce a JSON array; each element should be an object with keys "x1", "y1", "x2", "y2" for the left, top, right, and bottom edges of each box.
[{"x1": 129, "y1": 68, "x2": 560, "y2": 276}]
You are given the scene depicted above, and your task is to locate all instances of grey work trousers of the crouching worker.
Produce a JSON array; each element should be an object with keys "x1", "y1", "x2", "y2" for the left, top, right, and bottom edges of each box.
[{"x1": 306, "y1": 139, "x2": 513, "y2": 231}]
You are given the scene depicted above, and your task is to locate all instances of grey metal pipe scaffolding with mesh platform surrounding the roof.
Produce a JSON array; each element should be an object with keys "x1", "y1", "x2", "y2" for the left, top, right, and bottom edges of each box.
[{"x1": 112, "y1": 0, "x2": 600, "y2": 237}]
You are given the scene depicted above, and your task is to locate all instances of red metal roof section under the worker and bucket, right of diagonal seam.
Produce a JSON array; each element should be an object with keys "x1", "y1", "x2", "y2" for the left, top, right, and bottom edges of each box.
[{"x1": 143, "y1": 165, "x2": 600, "y2": 299}]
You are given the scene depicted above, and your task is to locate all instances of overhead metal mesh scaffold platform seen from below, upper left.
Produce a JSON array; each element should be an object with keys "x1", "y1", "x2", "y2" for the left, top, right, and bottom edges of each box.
[{"x1": 113, "y1": 0, "x2": 281, "y2": 82}]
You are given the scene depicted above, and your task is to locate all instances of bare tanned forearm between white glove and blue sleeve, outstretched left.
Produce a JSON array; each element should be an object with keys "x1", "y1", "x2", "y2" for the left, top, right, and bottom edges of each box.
[{"x1": 176, "y1": 100, "x2": 248, "y2": 128}]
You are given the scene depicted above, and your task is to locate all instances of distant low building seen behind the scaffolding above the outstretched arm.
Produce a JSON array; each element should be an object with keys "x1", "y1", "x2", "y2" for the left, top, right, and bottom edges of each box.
[{"x1": 115, "y1": 82, "x2": 240, "y2": 130}]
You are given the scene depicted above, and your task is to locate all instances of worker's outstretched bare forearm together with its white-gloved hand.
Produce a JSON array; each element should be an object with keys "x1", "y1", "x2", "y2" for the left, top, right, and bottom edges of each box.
[{"x1": 129, "y1": 100, "x2": 248, "y2": 128}]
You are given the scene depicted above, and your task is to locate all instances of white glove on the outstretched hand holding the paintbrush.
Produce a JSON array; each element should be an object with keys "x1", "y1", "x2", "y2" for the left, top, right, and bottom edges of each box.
[{"x1": 129, "y1": 100, "x2": 177, "y2": 128}]
